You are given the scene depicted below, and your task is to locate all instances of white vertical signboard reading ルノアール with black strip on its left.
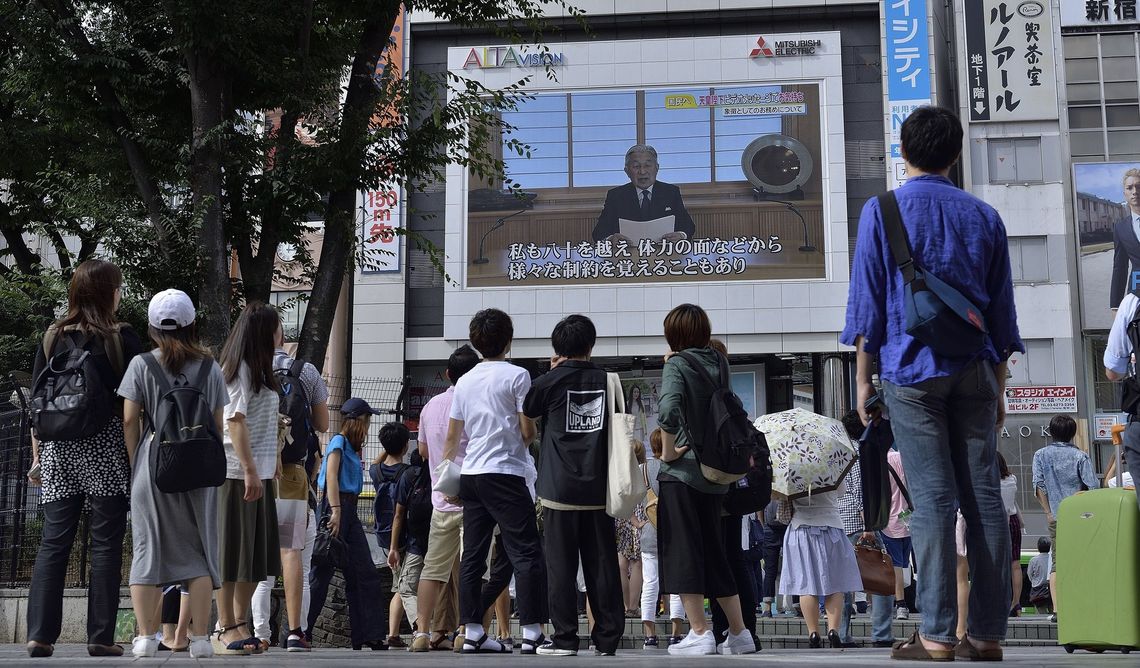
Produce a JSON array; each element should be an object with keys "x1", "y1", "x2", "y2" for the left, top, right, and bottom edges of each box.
[{"x1": 964, "y1": 0, "x2": 1057, "y2": 122}]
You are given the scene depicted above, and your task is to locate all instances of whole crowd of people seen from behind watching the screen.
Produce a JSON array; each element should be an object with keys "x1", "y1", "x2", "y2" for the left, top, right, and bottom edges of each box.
[{"x1": 27, "y1": 107, "x2": 1135, "y2": 660}]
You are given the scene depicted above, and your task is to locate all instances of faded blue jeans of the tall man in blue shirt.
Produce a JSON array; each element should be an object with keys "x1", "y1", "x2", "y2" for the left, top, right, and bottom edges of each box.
[{"x1": 885, "y1": 360, "x2": 1012, "y2": 643}]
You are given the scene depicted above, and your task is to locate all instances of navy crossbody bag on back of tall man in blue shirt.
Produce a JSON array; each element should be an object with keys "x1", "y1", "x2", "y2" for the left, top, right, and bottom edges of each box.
[{"x1": 878, "y1": 192, "x2": 990, "y2": 359}]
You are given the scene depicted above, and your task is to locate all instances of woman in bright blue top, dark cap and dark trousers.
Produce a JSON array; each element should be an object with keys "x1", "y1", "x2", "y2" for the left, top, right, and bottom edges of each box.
[{"x1": 309, "y1": 397, "x2": 388, "y2": 650}]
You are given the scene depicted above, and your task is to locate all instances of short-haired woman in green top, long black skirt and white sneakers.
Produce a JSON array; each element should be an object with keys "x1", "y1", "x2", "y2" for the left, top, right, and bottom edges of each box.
[{"x1": 657, "y1": 304, "x2": 756, "y2": 655}]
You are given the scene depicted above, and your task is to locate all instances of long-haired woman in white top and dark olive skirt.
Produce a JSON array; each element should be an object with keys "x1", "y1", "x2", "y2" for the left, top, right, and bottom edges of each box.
[{"x1": 214, "y1": 302, "x2": 282, "y2": 653}]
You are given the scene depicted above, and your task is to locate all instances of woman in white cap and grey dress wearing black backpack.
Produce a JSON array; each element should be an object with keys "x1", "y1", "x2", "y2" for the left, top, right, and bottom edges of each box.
[{"x1": 114, "y1": 290, "x2": 229, "y2": 658}]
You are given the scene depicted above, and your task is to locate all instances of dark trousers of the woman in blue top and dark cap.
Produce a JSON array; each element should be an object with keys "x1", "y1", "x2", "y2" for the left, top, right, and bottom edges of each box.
[{"x1": 308, "y1": 491, "x2": 388, "y2": 645}]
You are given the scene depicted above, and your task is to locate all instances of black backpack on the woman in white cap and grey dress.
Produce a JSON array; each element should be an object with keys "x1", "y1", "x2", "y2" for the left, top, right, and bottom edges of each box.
[{"x1": 143, "y1": 352, "x2": 226, "y2": 494}]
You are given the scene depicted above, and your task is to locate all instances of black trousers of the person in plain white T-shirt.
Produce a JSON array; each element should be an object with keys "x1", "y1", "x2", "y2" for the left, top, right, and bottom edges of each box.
[{"x1": 459, "y1": 473, "x2": 547, "y2": 624}]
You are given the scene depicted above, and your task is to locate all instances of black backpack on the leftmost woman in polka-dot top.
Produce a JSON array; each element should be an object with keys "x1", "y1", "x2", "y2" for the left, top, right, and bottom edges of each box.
[{"x1": 29, "y1": 327, "x2": 123, "y2": 441}]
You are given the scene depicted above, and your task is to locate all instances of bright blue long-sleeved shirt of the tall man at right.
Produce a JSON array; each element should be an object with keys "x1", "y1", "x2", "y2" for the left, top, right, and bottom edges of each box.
[{"x1": 839, "y1": 174, "x2": 1025, "y2": 385}]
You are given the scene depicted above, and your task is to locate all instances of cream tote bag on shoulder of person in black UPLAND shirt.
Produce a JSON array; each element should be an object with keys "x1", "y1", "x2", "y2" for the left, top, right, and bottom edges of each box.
[{"x1": 605, "y1": 374, "x2": 646, "y2": 520}]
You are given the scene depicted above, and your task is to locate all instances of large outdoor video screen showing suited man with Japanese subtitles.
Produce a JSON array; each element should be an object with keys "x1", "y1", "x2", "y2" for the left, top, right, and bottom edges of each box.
[{"x1": 465, "y1": 83, "x2": 825, "y2": 287}]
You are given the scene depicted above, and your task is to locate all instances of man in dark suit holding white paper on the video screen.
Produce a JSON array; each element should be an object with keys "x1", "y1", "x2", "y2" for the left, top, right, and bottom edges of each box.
[{"x1": 593, "y1": 144, "x2": 694, "y2": 245}]
